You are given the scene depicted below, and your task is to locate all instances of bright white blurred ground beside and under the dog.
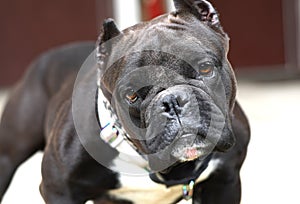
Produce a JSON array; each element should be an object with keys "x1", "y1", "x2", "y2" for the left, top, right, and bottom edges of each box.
[{"x1": 0, "y1": 80, "x2": 300, "y2": 204}]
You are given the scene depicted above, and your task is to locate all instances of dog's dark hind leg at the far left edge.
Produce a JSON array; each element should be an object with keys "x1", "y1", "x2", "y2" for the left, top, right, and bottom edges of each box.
[{"x1": 0, "y1": 77, "x2": 48, "y2": 203}]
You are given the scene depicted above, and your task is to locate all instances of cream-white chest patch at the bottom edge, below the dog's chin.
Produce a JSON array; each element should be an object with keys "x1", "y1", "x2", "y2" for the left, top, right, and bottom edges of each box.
[{"x1": 109, "y1": 159, "x2": 221, "y2": 204}]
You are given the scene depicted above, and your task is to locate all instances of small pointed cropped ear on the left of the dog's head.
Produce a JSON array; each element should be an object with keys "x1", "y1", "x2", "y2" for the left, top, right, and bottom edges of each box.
[{"x1": 96, "y1": 18, "x2": 122, "y2": 64}]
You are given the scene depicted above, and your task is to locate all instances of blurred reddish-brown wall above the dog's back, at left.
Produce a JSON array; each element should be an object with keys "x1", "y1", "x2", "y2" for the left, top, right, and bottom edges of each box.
[{"x1": 0, "y1": 0, "x2": 112, "y2": 85}]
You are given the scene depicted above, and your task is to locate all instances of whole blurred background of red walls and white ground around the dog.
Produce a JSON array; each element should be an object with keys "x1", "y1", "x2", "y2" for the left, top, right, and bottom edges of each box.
[{"x1": 0, "y1": 0, "x2": 300, "y2": 204}]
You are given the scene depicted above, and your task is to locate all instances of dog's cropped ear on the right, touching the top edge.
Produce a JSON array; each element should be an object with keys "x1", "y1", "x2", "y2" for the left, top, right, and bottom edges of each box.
[{"x1": 173, "y1": 0, "x2": 223, "y2": 32}]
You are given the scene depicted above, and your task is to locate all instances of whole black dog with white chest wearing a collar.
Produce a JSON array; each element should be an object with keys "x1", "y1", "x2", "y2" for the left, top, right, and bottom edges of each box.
[{"x1": 0, "y1": 0, "x2": 250, "y2": 204}]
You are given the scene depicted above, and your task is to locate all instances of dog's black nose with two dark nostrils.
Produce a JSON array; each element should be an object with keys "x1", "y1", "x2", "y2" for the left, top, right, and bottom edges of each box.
[{"x1": 162, "y1": 94, "x2": 186, "y2": 116}]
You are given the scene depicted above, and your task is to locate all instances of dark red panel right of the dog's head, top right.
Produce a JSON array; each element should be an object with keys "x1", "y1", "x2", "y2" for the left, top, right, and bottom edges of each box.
[{"x1": 213, "y1": 0, "x2": 285, "y2": 67}]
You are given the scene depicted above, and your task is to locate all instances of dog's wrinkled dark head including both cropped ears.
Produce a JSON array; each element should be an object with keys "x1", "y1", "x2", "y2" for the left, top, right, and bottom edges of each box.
[{"x1": 99, "y1": 0, "x2": 236, "y2": 171}]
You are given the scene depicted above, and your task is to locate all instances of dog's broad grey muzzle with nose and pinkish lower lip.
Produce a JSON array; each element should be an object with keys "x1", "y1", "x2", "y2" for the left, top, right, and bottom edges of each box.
[{"x1": 144, "y1": 85, "x2": 225, "y2": 171}]
